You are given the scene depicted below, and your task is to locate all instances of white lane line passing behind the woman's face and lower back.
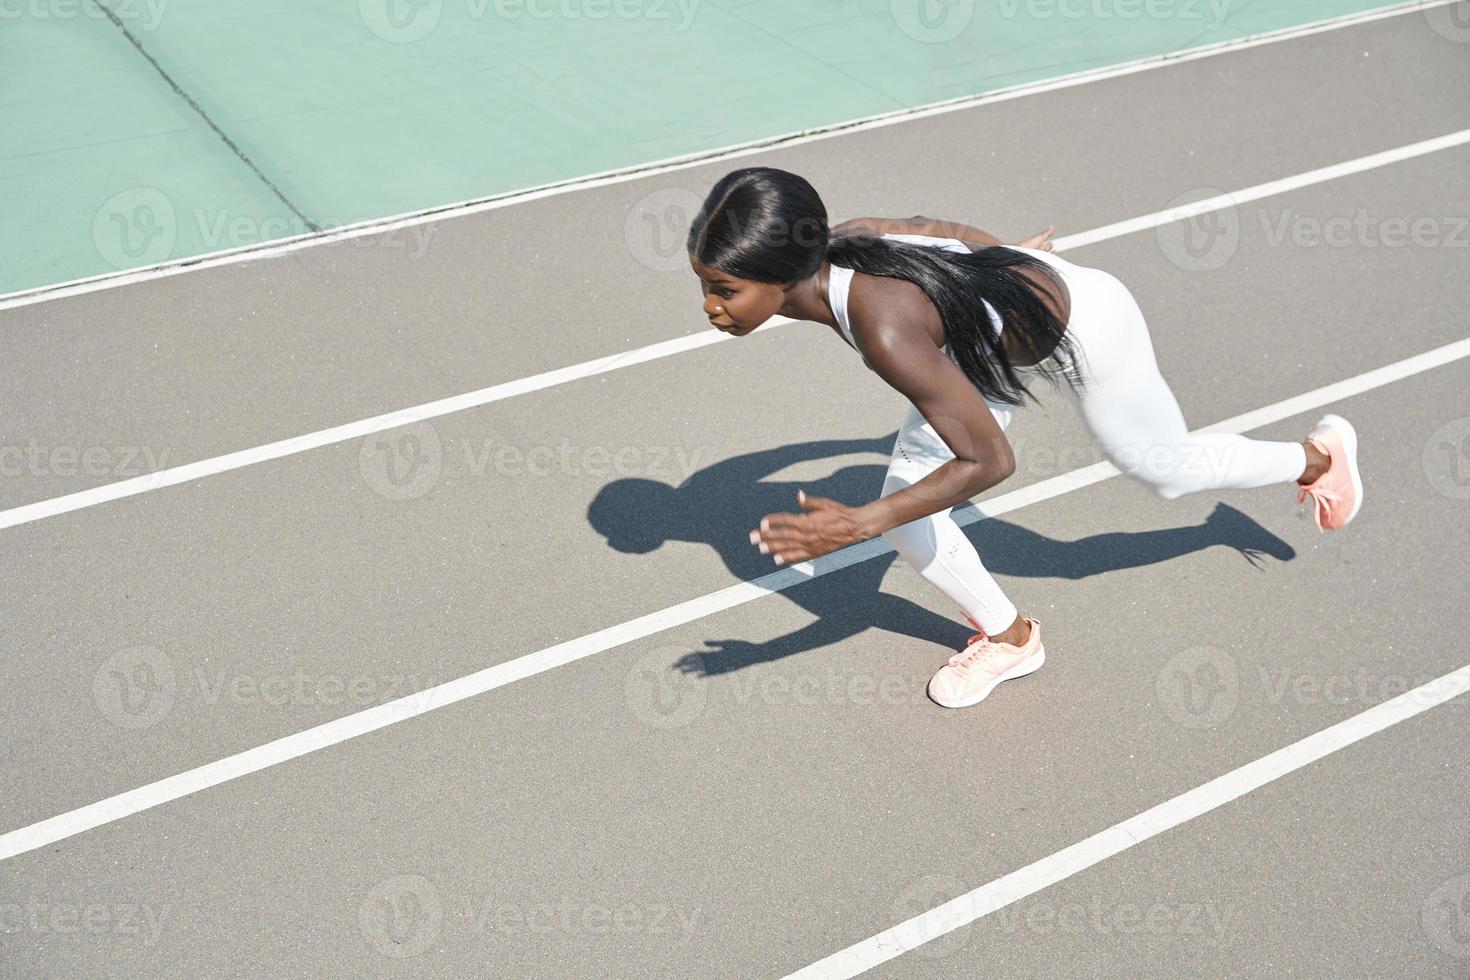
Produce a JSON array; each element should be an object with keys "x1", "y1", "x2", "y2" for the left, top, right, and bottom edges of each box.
[{"x1": 0, "y1": 129, "x2": 1470, "y2": 529}]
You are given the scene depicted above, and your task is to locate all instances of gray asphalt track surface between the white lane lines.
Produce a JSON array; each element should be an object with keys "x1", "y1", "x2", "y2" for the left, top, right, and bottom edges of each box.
[{"x1": 0, "y1": 15, "x2": 1470, "y2": 977}]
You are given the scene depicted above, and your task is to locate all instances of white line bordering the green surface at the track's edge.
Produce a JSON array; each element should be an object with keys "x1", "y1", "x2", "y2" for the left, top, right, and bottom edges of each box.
[{"x1": 0, "y1": 0, "x2": 1458, "y2": 310}]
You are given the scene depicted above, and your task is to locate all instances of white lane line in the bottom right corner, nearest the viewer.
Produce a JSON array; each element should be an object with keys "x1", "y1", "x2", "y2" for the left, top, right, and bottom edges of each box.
[{"x1": 786, "y1": 664, "x2": 1470, "y2": 980}]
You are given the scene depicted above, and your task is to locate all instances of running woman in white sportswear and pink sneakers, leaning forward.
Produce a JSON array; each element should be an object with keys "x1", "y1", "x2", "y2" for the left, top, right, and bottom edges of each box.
[{"x1": 688, "y1": 167, "x2": 1363, "y2": 708}]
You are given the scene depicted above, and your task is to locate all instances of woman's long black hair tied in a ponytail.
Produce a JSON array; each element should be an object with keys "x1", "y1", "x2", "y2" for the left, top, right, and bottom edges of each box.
[{"x1": 688, "y1": 167, "x2": 1080, "y2": 406}]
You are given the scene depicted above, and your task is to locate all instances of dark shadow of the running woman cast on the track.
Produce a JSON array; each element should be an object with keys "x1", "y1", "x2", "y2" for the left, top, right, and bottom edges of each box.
[{"x1": 588, "y1": 430, "x2": 1297, "y2": 676}]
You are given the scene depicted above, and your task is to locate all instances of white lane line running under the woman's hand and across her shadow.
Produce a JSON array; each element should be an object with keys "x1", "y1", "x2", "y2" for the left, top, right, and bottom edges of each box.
[{"x1": 0, "y1": 333, "x2": 1470, "y2": 861}]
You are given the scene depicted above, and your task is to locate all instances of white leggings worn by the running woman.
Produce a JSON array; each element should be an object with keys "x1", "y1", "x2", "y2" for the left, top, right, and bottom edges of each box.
[{"x1": 883, "y1": 250, "x2": 1307, "y2": 635}]
